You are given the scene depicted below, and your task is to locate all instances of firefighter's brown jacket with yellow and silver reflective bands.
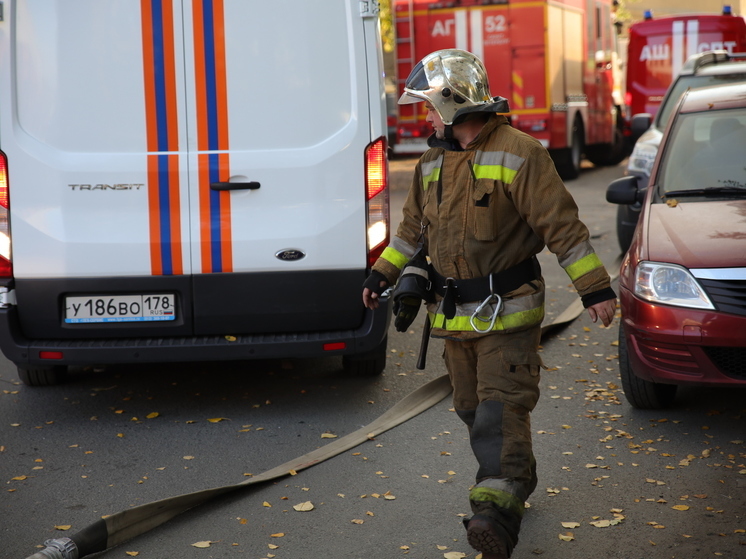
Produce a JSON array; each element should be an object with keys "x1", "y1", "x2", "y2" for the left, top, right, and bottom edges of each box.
[{"x1": 373, "y1": 114, "x2": 614, "y2": 339}]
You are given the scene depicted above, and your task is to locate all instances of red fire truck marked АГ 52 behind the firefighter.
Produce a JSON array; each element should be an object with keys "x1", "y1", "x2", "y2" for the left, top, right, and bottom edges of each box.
[{"x1": 393, "y1": 0, "x2": 625, "y2": 179}]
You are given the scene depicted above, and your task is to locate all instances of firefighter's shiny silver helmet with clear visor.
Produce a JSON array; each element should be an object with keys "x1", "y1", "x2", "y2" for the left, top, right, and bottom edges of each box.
[{"x1": 399, "y1": 49, "x2": 493, "y2": 125}]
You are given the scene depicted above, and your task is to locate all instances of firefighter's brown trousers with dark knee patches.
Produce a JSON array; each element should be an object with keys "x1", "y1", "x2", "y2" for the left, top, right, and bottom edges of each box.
[{"x1": 444, "y1": 326, "x2": 542, "y2": 547}]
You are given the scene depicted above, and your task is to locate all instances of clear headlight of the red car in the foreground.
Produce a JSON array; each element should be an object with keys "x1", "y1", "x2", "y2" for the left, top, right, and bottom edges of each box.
[{"x1": 634, "y1": 262, "x2": 715, "y2": 310}]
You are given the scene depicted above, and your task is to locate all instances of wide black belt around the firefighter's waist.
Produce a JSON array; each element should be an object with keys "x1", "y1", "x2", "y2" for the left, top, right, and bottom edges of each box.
[{"x1": 430, "y1": 256, "x2": 541, "y2": 319}]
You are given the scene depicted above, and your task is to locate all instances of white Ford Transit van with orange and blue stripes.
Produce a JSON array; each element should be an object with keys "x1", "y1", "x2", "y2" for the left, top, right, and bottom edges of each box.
[{"x1": 0, "y1": 0, "x2": 391, "y2": 385}]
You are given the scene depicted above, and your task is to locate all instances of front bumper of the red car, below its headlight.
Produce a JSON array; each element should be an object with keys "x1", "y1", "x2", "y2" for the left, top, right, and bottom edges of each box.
[{"x1": 620, "y1": 289, "x2": 746, "y2": 386}]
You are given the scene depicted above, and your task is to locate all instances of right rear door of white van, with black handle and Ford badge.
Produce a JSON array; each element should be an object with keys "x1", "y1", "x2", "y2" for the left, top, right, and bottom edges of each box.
[{"x1": 179, "y1": 0, "x2": 371, "y2": 334}]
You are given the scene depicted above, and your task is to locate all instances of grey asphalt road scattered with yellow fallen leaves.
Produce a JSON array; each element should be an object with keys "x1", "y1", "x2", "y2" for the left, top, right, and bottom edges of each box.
[{"x1": 0, "y1": 160, "x2": 746, "y2": 559}]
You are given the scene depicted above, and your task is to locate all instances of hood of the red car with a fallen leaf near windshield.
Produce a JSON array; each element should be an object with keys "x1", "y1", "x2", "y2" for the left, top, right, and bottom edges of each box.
[{"x1": 647, "y1": 200, "x2": 746, "y2": 268}]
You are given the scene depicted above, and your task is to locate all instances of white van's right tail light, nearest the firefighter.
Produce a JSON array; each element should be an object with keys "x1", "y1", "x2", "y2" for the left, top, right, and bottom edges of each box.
[{"x1": 365, "y1": 136, "x2": 391, "y2": 268}]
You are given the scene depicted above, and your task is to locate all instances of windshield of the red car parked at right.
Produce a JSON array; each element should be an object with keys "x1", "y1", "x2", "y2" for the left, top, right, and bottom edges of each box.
[{"x1": 657, "y1": 108, "x2": 746, "y2": 196}]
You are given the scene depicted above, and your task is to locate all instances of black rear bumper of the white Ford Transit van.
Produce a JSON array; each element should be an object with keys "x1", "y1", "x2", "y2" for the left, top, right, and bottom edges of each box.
[{"x1": 0, "y1": 297, "x2": 391, "y2": 367}]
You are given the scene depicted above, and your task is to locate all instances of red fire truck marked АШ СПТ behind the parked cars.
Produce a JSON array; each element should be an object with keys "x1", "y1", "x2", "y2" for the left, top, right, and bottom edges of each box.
[{"x1": 625, "y1": 6, "x2": 746, "y2": 120}]
